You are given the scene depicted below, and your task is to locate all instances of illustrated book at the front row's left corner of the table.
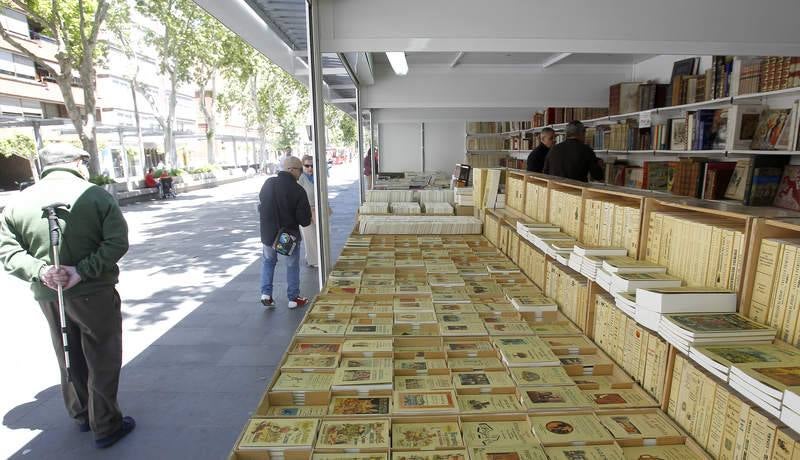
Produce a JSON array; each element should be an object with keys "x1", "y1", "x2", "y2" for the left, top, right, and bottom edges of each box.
[{"x1": 239, "y1": 418, "x2": 319, "y2": 452}]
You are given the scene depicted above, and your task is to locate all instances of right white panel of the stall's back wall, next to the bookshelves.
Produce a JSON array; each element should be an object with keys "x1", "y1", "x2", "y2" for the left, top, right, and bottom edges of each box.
[{"x1": 423, "y1": 121, "x2": 465, "y2": 172}]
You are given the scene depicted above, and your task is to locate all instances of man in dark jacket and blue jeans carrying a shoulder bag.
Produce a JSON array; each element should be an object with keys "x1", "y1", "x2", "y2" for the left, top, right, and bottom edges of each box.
[{"x1": 258, "y1": 156, "x2": 311, "y2": 308}]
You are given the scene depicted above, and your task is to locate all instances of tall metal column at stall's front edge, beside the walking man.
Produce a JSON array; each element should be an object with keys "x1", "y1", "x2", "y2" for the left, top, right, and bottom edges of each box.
[{"x1": 306, "y1": 0, "x2": 331, "y2": 289}]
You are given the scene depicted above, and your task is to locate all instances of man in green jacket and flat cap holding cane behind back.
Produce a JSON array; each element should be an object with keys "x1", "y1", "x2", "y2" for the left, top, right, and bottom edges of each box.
[{"x1": 0, "y1": 144, "x2": 136, "y2": 448}]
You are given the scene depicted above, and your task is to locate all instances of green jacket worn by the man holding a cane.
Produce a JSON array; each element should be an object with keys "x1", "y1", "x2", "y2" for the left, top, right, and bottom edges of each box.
[{"x1": 0, "y1": 168, "x2": 128, "y2": 301}]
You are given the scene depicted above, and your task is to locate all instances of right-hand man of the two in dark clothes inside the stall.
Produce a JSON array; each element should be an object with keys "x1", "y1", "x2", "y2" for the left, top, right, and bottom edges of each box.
[{"x1": 542, "y1": 121, "x2": 604, "y2": 182}]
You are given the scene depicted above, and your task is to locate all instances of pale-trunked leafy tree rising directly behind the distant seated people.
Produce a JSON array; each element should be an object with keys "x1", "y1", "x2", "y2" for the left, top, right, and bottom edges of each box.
[{"x1": 136, "y1": 0, "x2": 205, "y2": 166}]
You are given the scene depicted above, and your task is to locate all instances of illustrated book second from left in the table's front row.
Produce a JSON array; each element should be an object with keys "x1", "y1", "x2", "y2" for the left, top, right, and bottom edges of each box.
[{"x1": 316, "y1": 419, "x2": 391, "y2": 449}]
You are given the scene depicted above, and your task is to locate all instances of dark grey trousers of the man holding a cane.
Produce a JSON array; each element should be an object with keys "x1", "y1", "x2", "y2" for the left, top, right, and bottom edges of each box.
[{"x1": 39, "y1": 287, "x2": 122, "y2": 439}]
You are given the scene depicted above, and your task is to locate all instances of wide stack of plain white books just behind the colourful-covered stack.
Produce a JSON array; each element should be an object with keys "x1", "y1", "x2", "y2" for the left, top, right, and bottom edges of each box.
[{"x1": 634, "y1": 287, "x2": 736, "y2": 331}]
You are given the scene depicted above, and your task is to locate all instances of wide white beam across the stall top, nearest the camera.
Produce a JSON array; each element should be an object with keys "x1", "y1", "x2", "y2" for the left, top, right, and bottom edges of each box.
[{"x1": 319, "y1": 0, "x2": 800, "y2": 56}]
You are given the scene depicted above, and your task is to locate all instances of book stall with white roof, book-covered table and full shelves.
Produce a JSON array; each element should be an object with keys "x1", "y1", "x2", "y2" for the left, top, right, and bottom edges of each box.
[{"x1": 192, "y1": 0, "x2": 800, "y2": 460}]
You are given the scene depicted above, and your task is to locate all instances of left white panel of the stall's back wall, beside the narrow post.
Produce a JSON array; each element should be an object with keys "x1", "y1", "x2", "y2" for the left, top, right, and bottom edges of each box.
[{"x1": 378, "y1": 123, "x2": 424, "y2": 172}]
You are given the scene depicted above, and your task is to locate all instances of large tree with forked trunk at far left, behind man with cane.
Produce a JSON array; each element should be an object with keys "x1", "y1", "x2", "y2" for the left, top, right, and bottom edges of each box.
[{"x1": 0, "y1": 0, "x2": 126, "y2": 174}]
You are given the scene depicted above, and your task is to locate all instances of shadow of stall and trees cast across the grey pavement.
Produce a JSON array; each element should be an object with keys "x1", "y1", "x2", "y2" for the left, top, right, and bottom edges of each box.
[{"x1": 3, "y1": 164, "x2": 358, "y2": 459}]
